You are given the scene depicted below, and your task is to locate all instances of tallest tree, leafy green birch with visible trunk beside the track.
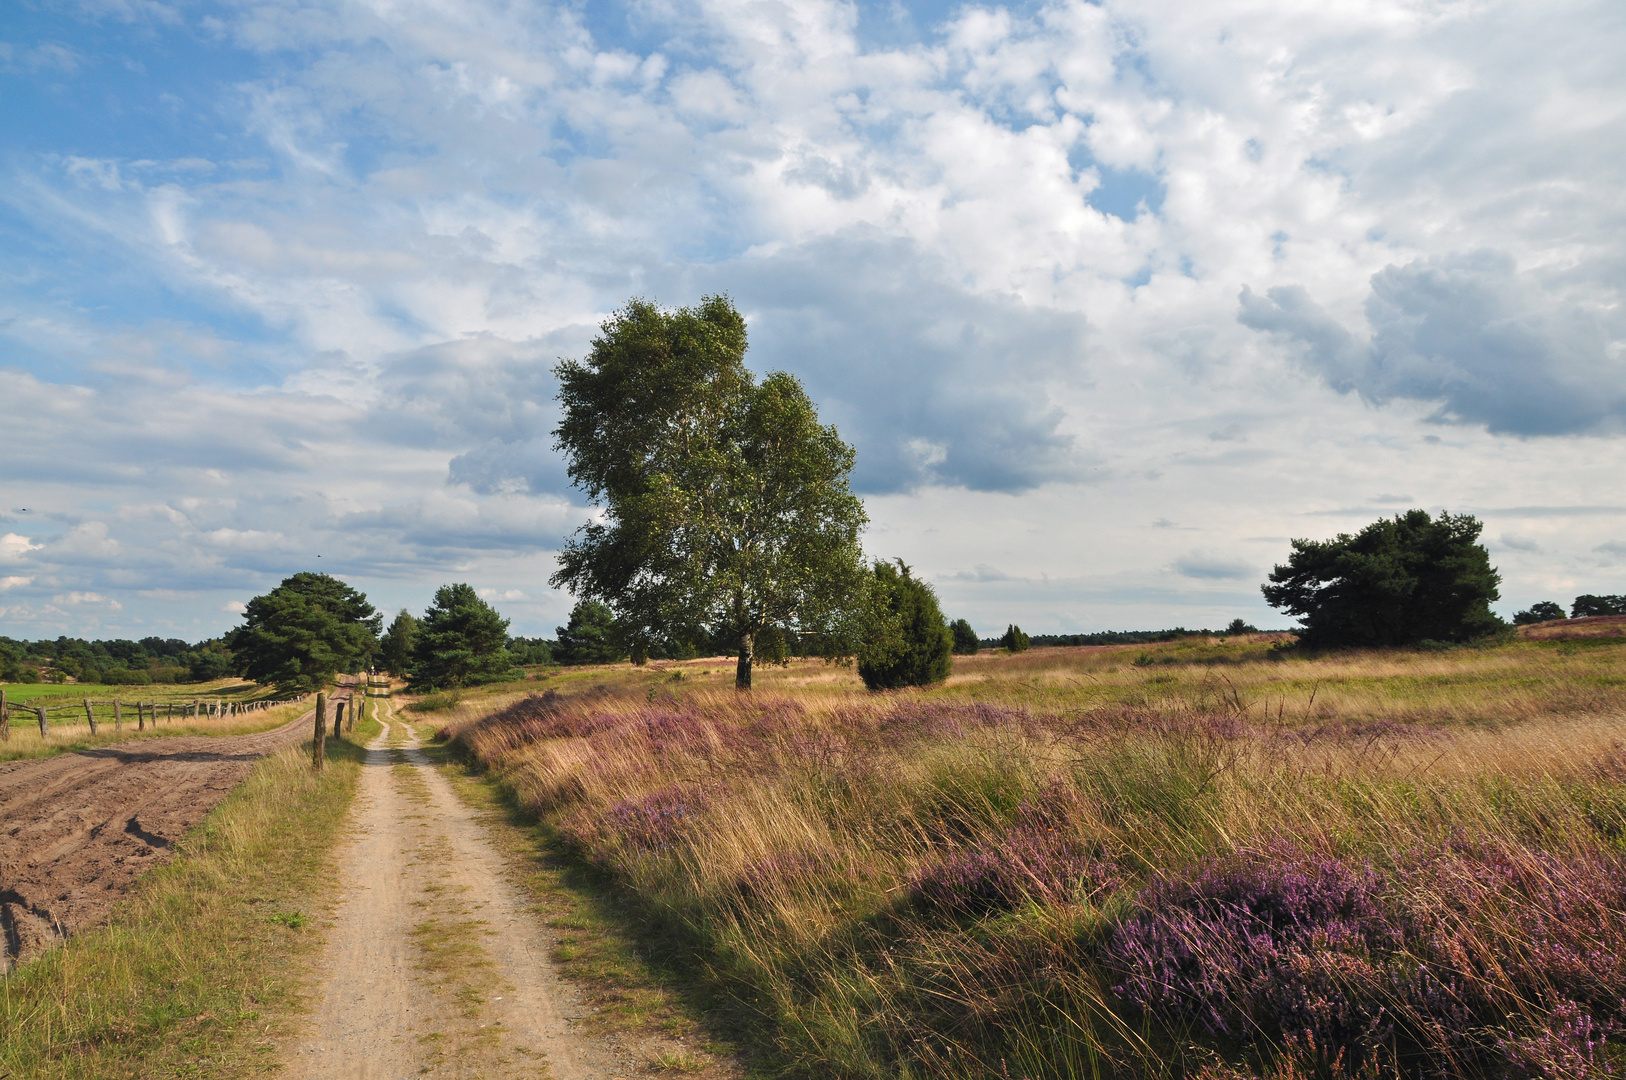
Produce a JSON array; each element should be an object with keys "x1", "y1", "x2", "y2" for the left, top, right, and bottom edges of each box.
[{"x1": 553, "y1": 296, "x2": 867, "y2": 688}]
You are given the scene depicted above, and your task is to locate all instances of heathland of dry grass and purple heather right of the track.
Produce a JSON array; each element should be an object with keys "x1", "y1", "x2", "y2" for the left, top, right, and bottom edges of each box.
[{"x1": 447, "y1": 639, "x2": 1626, "y2": 1078}]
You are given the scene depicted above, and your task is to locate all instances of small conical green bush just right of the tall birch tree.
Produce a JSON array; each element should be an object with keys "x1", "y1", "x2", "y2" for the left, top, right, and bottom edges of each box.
[{"x1": 859, "y1": 560, "x2": 954, "y2": 690}]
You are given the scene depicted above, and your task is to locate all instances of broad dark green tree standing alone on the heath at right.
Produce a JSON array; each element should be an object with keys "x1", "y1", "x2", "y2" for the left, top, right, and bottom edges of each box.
[{"x1": 1262, "y1": 511, "x2": 1504, "y2": 647}]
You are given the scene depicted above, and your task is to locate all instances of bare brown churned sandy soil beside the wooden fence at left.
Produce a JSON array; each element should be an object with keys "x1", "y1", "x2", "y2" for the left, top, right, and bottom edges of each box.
[{"x1": 0, "y1": 696, "x2": 346, "y2": 971}]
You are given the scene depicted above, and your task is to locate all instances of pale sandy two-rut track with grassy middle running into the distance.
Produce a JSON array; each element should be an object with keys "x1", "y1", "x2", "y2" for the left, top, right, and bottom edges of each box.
[{"x1": 285, "y1": 703, "x2": 611, "y2": 1080}]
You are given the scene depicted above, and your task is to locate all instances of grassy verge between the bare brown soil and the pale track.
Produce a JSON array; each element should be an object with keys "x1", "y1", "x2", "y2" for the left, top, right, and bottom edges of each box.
[{"x1": 0, "y1": 721, "x2": 379, "y2": 1080}]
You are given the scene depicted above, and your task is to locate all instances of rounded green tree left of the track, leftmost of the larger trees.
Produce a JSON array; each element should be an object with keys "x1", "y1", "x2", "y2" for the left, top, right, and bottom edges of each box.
[{"x1": 226, "y1": 573, "x2": 384, "y2": 693}]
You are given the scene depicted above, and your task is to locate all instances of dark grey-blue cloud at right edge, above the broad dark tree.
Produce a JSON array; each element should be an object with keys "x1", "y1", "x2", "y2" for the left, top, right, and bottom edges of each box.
[{"x1": 1237, "y1": 250, "x2": 1626, "y2": 436}]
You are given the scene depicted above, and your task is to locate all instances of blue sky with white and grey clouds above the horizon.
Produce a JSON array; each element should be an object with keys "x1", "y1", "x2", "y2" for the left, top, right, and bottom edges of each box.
[{"x1": 0, "y1": 0, "x2": 1626, "y2": 641}]
